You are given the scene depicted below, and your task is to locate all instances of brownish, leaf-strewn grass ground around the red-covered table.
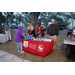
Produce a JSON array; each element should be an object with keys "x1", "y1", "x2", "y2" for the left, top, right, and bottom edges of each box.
[{"x1": 0, "y1": 30, "x2": 73, "y2": 62}]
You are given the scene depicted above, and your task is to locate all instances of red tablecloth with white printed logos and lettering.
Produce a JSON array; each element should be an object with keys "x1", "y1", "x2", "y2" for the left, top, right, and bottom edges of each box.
[{"x1": 23, "y1": 39, "x2": 54, "y2": 57}]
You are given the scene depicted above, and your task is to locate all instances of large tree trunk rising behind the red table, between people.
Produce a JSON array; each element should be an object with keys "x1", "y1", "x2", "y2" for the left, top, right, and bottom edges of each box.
[{"x1": 31, "y1": 12, "x2": 40, "y2": 35}]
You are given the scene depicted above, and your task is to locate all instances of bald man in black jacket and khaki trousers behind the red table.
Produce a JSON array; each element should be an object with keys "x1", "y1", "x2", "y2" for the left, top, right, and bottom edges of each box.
[{"x1": 47, "y1": 19, "x2": 59, "y2": 43}]
